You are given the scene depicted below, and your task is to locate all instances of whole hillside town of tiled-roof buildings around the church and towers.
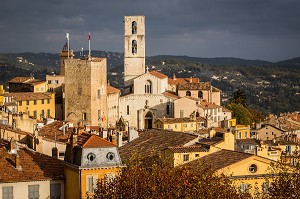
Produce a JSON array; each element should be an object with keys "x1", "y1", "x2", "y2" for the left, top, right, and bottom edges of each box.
[{"x1": 0, "y1": 16, "x2": 300, "y2": 199}]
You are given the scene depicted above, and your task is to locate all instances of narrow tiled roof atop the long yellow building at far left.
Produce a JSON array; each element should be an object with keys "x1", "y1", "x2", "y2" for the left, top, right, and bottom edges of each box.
[{"x1": 4, "y1": 92, "x2": 51, "y2": 101}]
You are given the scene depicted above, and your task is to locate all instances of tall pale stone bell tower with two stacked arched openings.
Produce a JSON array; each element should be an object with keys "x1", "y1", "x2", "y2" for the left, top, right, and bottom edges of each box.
[{"x1": 124, "y1": 16, "x2": 145, "y2": 90}]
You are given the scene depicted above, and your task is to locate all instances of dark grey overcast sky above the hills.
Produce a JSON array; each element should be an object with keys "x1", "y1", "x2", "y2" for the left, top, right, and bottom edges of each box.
[{"x1": 0, "y1": 0, "x2": 300, "y2": 61}]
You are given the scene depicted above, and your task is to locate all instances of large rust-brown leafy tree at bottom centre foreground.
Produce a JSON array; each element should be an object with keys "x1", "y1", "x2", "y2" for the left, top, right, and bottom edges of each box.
[{"x1": 94, "y1": 159, "x2": 250, "y2": 198}]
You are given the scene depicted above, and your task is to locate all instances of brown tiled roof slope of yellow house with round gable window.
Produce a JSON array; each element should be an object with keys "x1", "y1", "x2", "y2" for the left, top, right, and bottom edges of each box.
[{"x1": 184, "y1": 149, "x2": 253, "y2": 170}]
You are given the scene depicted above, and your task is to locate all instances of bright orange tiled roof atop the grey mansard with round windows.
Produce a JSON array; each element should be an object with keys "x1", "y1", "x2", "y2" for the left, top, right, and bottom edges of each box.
[{"x1": 77, "y1": 133, "x2": 116, "y2": 148}]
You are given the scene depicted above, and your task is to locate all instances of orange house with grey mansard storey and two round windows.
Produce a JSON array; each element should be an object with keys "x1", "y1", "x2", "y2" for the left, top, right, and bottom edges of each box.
[{"x1": 65, "y1": 133, "x2": 123, "y2": 199}]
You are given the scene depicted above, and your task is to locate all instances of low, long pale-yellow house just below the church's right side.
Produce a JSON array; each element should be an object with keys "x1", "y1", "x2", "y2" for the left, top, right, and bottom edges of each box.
[{"x1": 154, "y1": 117, "x2": 205, "y2": 132}]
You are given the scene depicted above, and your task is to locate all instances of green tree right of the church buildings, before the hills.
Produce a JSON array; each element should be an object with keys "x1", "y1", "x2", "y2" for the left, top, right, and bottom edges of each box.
[{"x1": 226, "y1": 103, "x2": 252, "y2": 125}]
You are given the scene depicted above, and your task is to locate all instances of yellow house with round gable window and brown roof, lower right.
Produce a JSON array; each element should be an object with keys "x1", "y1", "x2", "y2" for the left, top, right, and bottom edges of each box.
[{"x1": 183, "y1": 149, "x2": 272, "y2": 194}]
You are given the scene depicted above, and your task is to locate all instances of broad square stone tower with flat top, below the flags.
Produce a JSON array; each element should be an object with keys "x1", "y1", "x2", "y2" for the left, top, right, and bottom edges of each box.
[{"x1": 65, "y1": 58, "x2": 107, "y2": 127}]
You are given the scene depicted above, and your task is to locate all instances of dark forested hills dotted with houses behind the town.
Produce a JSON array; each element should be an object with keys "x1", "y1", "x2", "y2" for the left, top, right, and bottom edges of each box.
[{"x1": 0, "y1": 50, "x2": 300, "y2": 114}]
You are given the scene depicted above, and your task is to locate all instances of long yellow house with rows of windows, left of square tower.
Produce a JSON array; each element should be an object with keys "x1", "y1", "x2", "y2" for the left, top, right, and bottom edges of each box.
[{"x1": 4, "y1": 92, "x2": 55, "y2": 120}]
